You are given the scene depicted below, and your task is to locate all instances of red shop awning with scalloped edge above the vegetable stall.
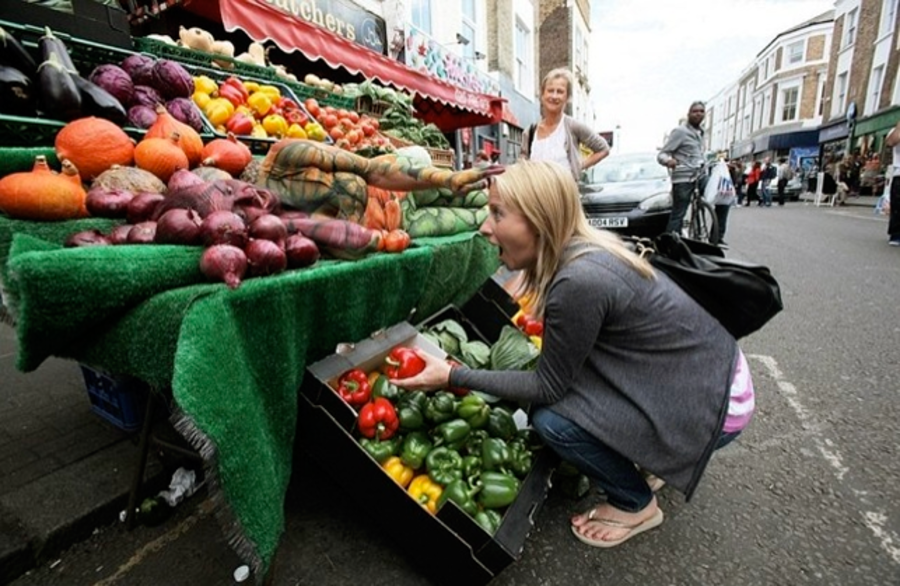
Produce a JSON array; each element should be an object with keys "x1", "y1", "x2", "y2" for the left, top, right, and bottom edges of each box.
[{"x1": 202, "y1": 0, "x2": 505, "y2": 132}]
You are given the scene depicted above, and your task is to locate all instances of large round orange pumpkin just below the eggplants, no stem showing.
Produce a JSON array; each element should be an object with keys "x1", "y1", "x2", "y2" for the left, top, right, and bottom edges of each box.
[{"x1": 54, "y1": 116, "x2": 134, "y2": 181}]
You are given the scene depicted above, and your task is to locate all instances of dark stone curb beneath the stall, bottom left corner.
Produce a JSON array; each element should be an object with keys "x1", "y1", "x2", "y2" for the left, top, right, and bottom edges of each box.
[{"x1": 0, "y1": 439, "x2": 165, "y2": 584}]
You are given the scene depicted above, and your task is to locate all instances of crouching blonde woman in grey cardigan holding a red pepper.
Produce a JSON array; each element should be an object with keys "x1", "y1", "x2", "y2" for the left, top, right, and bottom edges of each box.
[{"x1": 391, "y1": 162, "x2": 753, "y2": 547}]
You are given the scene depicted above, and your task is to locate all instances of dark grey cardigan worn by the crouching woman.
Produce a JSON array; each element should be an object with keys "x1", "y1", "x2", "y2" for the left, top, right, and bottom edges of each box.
[{"x1": 450, "y1": 251, "x2": 738, "y2": 498}]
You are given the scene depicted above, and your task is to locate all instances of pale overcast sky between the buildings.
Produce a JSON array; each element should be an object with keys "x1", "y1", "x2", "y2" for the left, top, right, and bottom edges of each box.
[{"x1": 590, "y1": 0, "x2": 834, "y2": 153}]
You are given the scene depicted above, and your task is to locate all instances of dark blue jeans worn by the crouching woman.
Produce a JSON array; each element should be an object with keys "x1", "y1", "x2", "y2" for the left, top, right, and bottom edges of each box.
[{"x1": 531, "y1": 407, "x2": 740, "y2": 513}]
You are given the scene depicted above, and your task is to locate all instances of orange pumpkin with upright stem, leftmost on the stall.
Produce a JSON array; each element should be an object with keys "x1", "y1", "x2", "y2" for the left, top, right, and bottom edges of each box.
[{"x1": 0, "y1": 155, "x2": 88, "y2": 220}]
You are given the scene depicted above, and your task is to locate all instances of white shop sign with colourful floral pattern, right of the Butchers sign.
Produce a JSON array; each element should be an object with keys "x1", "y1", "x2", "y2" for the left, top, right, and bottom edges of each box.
[{"x1": 405, "y1": 23, "x2": 500, "y2": 96}]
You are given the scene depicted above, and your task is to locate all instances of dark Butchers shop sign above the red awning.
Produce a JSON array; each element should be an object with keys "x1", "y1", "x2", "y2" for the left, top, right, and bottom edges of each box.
[{"x1": 256, "y1": 0, "x2": 387, "y2": 55}]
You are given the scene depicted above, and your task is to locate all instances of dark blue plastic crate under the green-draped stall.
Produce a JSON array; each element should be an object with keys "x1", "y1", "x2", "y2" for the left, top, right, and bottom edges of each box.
[{"x1": 79, "y1": 364, "x2": 149, "y2": 431}]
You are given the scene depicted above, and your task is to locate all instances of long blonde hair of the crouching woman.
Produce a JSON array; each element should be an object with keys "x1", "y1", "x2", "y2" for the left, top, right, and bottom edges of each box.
[{"x1": 493, "y1": 161, "x2": 655, "y2": 316}]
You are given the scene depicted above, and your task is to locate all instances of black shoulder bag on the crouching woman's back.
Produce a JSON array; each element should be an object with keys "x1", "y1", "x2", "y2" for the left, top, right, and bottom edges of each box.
[{"x1": 626, "y1": 233, "x2": 784, "y2": 339}]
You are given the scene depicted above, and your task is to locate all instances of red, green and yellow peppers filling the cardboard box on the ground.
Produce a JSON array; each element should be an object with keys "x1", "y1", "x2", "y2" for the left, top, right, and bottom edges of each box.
[{"x1": 335, "y1": 346, "x2": 542, "y2": 535}]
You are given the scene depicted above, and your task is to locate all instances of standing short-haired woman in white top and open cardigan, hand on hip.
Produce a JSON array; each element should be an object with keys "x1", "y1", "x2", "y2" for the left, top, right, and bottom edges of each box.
[{"x1": 521, "y1": 68, "x2": 609, "y2": 181}]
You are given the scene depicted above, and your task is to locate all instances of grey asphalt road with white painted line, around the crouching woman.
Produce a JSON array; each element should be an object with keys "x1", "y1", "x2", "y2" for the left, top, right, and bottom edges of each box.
[{"x1": 8, "y1": 203, "x2": 900, "y2": 586}]
